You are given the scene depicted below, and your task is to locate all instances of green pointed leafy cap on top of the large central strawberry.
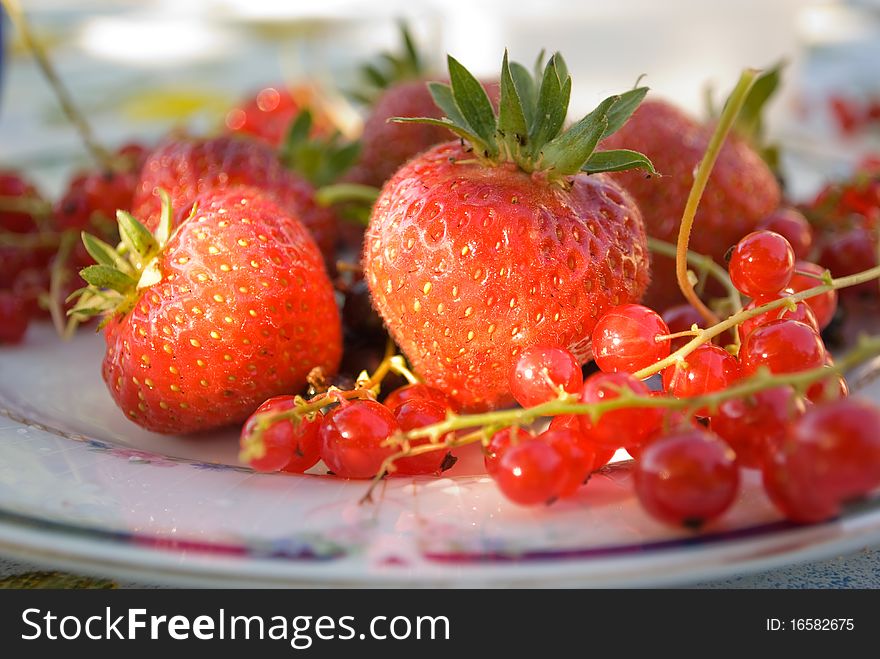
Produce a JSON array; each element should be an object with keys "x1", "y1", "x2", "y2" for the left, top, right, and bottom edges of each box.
[{"x1": 392, "y1": 51, "x2": 657, "y2": 185}]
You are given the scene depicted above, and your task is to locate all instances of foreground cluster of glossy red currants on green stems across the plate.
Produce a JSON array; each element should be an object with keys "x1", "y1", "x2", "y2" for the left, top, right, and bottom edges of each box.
[{"x1": 241, "y1": 229, "x2": 880, "y2": 528}]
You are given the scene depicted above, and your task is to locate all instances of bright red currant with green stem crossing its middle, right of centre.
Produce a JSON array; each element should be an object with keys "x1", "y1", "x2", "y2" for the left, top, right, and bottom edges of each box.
[{"x1": 580, "y1": 373, "x2": 662, "y2": 450}]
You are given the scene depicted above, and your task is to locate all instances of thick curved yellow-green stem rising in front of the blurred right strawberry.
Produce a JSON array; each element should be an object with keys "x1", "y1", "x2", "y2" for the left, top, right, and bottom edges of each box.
[{"x1": 675, "y1": 69, "x2": 758, "y2": 324}]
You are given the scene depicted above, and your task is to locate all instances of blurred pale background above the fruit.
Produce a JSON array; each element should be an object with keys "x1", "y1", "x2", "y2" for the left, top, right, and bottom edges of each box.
[{"x1": 0, "y1": 0, "x2": 880, "y2": 197}]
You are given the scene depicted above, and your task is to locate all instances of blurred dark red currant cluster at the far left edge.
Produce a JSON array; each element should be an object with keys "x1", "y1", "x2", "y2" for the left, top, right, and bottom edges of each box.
[{"x1": 0, "y1": 144, "x2": 146, "y2": 344}]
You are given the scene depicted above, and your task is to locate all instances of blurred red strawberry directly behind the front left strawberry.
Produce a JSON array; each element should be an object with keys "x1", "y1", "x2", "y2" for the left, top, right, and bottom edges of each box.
[{"x1": 132, "y1": 136, "x2": 336, "y2": 263}]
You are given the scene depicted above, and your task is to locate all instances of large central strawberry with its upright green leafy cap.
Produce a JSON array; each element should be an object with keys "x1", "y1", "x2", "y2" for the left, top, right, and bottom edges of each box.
[{"x1": 363, "y1": 55, "x2": 653, "y2": 410}]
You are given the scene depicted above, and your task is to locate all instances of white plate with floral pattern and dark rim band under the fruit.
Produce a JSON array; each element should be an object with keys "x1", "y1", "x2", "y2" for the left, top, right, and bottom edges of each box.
[{"x1": 0, "y1": 326, "x2": 880, "y2": 587}]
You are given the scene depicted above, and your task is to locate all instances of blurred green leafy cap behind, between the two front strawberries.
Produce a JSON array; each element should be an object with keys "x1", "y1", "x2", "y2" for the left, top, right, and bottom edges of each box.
[{"x1": 278, "y1": 109, "x2": 361, "y2": 187}]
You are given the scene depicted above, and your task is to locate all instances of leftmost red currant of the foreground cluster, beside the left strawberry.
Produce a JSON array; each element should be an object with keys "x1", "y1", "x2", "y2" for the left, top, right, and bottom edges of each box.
[{"x1": 241, "y1": 395, "x2": 322, "y2": 473}]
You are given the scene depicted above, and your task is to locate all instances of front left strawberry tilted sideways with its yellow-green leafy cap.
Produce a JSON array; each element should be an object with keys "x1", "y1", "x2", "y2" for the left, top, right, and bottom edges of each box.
[{"x1": 73, "y1": 187, "x2": 342, "y2": 433}]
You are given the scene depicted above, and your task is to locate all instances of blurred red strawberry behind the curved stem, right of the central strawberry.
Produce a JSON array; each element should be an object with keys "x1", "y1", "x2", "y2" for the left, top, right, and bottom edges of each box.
[{"x1": 602, "y1": 101, "x2": 780, "y2": 309}]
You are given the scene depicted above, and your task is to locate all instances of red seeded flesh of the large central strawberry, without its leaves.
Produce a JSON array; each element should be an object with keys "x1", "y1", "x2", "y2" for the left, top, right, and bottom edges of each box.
[{"x1": 363, "y1": 142, "x2": 648, "y2": 411}]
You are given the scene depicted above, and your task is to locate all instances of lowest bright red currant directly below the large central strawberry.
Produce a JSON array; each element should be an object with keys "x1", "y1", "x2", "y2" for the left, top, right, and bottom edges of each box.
[{"x1": 492, "y1": 439, "x2": 568, "y2": 506}]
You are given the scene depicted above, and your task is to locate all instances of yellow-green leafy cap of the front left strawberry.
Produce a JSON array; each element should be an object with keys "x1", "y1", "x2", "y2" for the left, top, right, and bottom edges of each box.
[{"x1": 68, "y1": 190, "x2": 177, "y2": 329}]
